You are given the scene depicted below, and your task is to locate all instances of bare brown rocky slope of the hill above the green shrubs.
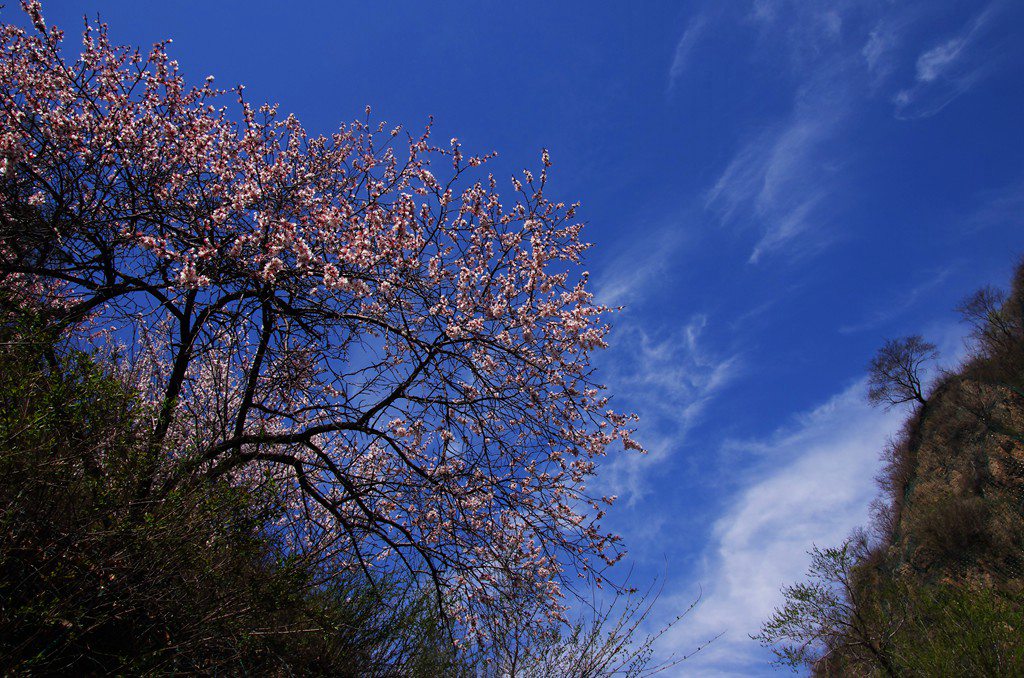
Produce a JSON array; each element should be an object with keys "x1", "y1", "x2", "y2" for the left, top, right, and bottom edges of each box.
[{"x1": 877, "y1": 268, "x2": 1024, "y2": 592}]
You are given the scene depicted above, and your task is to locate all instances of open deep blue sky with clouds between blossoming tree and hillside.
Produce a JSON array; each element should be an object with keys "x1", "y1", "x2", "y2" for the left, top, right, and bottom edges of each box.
[{"x1": 19, "y1": 0, "x2": 1024, "y2": 676}]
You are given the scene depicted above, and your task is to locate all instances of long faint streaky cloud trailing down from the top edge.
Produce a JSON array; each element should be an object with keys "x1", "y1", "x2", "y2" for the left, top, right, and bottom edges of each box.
[{"x1": 705, "y1": 0, "x2": 864, "y2": 263}]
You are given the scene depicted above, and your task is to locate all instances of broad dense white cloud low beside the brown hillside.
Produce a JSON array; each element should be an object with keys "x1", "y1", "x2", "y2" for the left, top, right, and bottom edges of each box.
[{"x1": 662, "y1": 381, "x2": 904, "y2": 676}]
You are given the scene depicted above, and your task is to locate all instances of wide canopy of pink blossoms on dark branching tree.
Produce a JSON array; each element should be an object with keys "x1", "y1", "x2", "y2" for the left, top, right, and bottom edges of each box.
[{"x1": 0, "y1": 1, "x2": 638, "y2": 647}]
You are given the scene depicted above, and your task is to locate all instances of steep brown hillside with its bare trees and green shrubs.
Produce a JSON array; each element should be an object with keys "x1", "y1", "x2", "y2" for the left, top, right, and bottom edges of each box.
[{"x1": 756, "y1": 263, "x2": 1024, "y2": 676}]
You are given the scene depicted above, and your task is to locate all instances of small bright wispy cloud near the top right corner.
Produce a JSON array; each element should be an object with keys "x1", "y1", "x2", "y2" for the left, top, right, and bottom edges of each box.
[{"x1": 893, "y1": 1, "x2": 1004, "y2": 120}]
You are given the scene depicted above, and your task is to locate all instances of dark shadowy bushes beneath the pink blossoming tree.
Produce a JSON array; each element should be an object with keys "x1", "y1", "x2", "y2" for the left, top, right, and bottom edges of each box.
[{"x1": 0, "y1": 314, "x2": 465, "y2": 675}]
